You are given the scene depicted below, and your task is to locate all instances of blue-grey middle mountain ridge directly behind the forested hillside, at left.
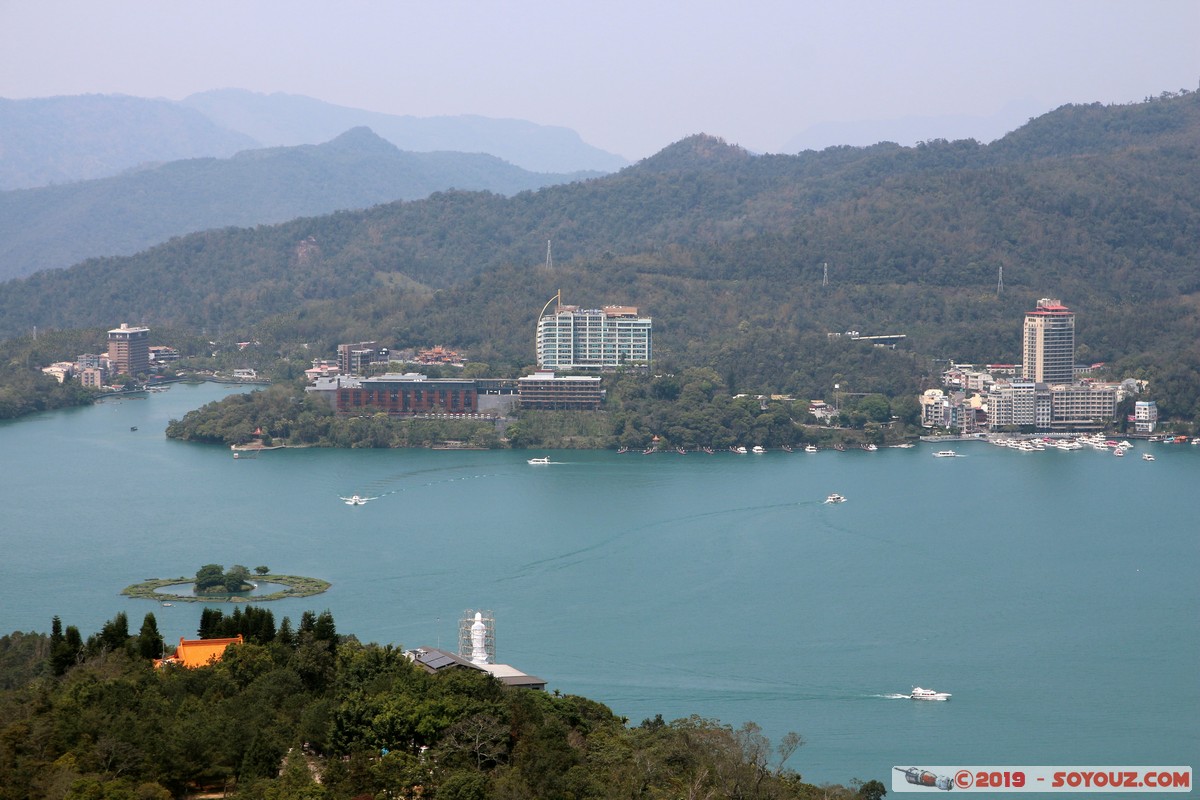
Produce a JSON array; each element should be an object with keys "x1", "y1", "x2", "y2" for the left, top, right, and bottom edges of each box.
[{"x1": 0, "y1": 128, "x2": 590, "y2": 279}]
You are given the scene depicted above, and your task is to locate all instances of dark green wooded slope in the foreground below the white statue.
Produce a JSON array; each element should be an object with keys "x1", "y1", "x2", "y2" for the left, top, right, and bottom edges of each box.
[{"x1": 0, "y1": 606, "x2": 888, "y2": 800}]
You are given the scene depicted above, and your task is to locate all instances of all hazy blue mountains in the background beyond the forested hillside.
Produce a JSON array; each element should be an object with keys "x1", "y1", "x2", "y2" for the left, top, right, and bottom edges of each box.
[{"x1": 0, "y1": 89, "x2": 1051, "y2": 279}]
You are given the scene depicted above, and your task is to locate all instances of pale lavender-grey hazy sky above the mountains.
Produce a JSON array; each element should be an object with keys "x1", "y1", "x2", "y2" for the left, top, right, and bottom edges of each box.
[{"x1": 0, "y1": 0, "x2": 1200, "y2": 160}]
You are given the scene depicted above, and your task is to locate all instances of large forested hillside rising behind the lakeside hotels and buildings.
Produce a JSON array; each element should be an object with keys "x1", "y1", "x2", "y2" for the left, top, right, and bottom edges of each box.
[{"x1": 0, "y1": 94, "x2": 1200, "y2": 407}]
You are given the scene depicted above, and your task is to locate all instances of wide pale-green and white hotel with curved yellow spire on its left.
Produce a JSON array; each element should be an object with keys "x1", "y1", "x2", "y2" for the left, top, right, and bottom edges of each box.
[{"x1": 538, "y1": 306, "x2": 653, "y2": 369}]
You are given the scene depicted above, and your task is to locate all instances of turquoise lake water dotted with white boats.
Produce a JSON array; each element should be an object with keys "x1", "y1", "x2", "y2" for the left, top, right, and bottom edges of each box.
[{"x1": 0, "y1": 384, "x2": 1200, "y2": 786}]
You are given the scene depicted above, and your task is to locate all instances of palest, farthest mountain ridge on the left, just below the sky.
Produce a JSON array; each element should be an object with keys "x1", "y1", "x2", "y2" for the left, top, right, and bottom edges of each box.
[{"x1": 0, "y1": 90, "x2": 628, "y2": 191}]
